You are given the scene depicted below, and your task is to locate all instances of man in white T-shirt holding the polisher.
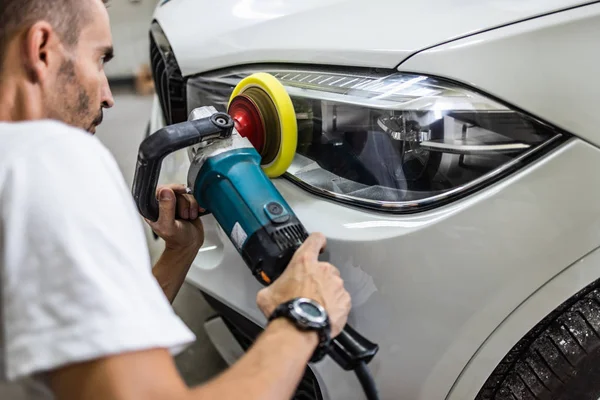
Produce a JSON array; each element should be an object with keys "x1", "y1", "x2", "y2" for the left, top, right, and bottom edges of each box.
[{"x1": 0, "y1": 0, "x2": 350, "y2": 400}]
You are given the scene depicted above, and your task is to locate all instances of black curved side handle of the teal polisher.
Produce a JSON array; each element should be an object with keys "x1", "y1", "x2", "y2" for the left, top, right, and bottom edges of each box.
[{"x1": 133, "y1": 113, "x2": 234, "y2": 222}]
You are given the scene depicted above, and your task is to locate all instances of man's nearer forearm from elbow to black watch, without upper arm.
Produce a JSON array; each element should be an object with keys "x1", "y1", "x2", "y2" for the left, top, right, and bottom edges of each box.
[{"x1": 191, "y1": 319, "x2": 318, "y2": 400}]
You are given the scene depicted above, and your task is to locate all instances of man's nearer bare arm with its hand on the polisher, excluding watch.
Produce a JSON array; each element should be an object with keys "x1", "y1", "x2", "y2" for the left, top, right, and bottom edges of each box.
[{"x1": 49, "y1": 234, "x2": 350, "y2": 400}]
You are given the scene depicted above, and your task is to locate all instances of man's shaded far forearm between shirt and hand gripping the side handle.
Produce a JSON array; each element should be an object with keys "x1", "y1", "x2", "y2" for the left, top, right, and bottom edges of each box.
[{"x1": 152, "y1": 247, "x2": 198, "y2": 303}]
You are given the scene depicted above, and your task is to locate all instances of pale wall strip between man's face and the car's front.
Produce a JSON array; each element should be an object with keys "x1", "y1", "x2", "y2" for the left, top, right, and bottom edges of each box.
[{"x1": 106, "y1": 0, "x2": 158, "y2": 78}]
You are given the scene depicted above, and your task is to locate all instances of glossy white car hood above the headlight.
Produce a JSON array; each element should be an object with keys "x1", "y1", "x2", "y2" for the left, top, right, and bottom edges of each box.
[{"x1": 155, "y1": 0, "x2": 590, "y2": 76}]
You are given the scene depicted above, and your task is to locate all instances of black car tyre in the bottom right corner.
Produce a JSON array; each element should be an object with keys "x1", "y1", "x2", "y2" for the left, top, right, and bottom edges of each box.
[{"x1": 476, "y1": 285, "x2": 600, "y2": 400}]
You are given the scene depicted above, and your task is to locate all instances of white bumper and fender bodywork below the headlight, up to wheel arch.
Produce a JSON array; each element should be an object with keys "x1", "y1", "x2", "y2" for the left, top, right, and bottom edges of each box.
[{"x1": 154, "y1": 135, "x2": 600, "y2": 400}]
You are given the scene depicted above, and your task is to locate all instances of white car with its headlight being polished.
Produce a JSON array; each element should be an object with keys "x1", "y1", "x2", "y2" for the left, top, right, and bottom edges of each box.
[{"x1": 142, "y1": 0, "x2": 600, "y2": 400}]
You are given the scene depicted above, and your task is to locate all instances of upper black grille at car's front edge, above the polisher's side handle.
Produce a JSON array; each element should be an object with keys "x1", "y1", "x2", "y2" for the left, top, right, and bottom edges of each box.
[{"x1": 150, "y1": 22, "x2": 187, "y2": 125}]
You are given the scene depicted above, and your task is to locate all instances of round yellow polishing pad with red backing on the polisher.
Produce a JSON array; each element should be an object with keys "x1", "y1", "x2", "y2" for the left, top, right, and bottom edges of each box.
[{"x1": 228, "y1": 72, "x2": 298, "y2": 178}]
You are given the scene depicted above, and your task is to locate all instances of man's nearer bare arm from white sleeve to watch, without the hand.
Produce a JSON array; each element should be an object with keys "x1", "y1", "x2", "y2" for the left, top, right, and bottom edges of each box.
[{"x1": 49, "y1": 319, "x2": 318, "y2": 400}]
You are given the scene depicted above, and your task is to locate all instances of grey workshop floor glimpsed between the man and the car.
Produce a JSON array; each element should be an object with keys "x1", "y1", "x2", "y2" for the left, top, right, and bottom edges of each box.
[{"x1": 95, "y1": 88, "x2": 226, "y2": 388}]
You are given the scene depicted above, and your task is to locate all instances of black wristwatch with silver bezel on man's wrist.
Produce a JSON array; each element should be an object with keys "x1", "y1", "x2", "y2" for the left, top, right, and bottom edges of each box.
[{"x1": 269, "y1": 297, "x2": 331, "y2": 363}]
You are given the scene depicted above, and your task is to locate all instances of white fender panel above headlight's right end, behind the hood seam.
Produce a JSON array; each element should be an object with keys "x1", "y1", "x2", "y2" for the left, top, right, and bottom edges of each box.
[{"x1": 399, "y1": 3, "x2": 600, "y2": 145}]
